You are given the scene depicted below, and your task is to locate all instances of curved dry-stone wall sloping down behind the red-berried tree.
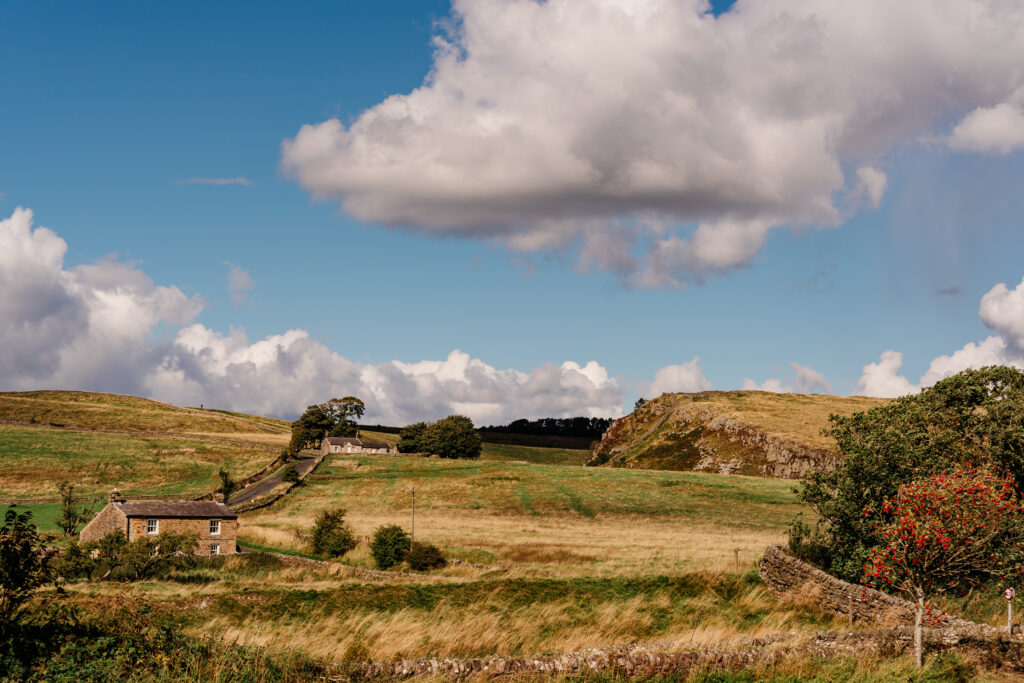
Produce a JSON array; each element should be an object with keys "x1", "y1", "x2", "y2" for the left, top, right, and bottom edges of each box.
[{"x1": 761, "y1": 546, "x2": 992, "y2": 631}]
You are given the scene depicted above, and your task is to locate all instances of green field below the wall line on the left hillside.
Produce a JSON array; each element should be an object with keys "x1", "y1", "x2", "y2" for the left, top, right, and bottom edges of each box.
[{"x1": 0, "y1": 425, "x2": 274, "y2": 498}]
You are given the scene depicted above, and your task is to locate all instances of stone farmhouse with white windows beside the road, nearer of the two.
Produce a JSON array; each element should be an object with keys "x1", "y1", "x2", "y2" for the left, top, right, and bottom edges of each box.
[{"x1": 79, "y1": 490, "x2": 239, "y2": 555}]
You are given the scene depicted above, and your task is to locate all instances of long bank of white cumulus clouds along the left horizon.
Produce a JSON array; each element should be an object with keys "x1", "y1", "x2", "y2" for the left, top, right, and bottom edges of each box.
[{"x1": 0, "y1": 209, "x2": 623, "y2": 424}]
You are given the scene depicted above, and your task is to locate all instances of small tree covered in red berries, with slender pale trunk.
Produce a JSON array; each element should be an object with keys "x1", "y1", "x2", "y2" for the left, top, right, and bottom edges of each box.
[{"x1": 862, "y1": 465, "x2": 1024, "y2": 667}]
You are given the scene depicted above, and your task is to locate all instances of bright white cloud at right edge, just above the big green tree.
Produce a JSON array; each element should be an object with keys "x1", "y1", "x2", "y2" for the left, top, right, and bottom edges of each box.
[{"x1": 857, "y1": 280, "x2": 1024, "y2": 398}]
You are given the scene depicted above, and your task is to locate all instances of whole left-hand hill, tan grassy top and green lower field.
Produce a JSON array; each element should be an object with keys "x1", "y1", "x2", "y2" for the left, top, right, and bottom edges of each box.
[{"x1": 0, "y1": 391, "x2": 290, "y2": 498}]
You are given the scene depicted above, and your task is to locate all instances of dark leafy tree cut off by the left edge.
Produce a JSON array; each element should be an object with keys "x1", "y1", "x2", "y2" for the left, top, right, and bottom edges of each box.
[{"x1": 0, "y1": 507, "x2": 47, "y2": 636}]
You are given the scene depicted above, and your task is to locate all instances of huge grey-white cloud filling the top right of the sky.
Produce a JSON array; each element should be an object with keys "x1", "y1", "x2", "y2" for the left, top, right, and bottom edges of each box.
[{"x1": 282, "y1": 0, "x2": 1024, "y2": 286}]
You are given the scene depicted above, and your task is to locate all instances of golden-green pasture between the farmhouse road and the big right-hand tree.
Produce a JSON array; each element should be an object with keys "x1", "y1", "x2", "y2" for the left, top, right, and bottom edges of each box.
[{"x1": 241, "y1": 456, "x2": 801, "y2": 575}]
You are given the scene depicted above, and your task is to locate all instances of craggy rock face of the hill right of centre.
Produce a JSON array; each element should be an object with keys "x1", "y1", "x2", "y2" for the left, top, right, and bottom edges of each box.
[{"x1": 588, "y1": 394, "x2": 840, "y2": 479}]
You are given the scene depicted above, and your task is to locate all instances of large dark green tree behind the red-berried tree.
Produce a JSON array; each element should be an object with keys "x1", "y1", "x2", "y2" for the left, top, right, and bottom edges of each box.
[{"x1": 790, "y1": 367, "x2": 1024, "y2": 581}]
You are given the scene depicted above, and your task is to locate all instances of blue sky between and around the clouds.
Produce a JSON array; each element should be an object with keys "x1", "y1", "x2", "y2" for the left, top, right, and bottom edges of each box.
[{"x1": 0, "y1": 0, "x2": 1024, "y2": 421}]
